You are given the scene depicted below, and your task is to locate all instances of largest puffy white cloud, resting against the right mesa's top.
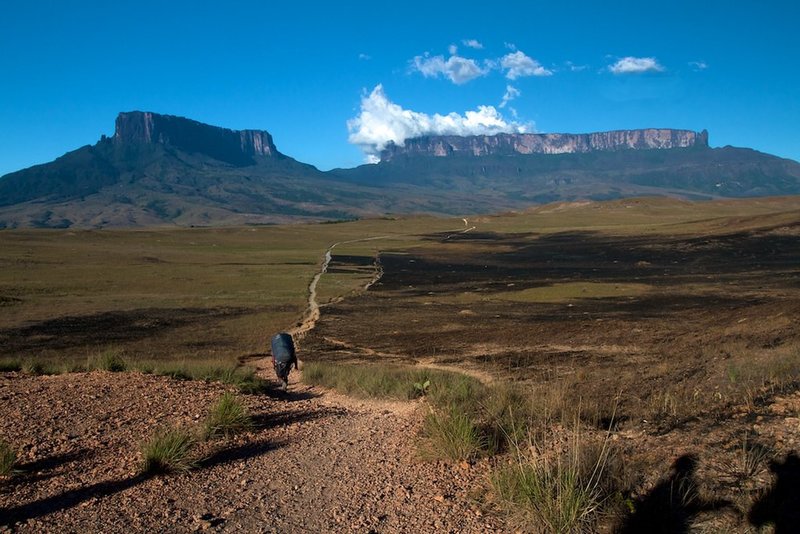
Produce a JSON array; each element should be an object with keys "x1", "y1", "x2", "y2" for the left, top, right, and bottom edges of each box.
[{"x1": 347, "y1": 85, "x2": 531, "y2": 163}]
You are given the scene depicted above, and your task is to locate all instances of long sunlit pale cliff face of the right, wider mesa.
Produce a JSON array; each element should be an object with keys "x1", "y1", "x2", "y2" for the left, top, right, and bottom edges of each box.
[{"x1": 381, "y1": 128, "x2": 708, "y2": 161}]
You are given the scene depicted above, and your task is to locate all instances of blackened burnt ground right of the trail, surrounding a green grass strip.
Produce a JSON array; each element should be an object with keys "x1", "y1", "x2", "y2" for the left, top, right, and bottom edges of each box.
[{"x1": 306, "y1": 231, "x2": 800, "y2": 386}]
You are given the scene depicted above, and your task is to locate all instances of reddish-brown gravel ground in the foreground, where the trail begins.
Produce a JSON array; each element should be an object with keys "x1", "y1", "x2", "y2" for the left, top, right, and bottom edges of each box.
[{"x1": 0, "y1": 371, "x2": 506, "y2": 533}]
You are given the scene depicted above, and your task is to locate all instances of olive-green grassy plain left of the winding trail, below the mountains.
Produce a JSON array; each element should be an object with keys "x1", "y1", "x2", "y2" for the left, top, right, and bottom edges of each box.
[{"x1": 0, "y1": 218, "x2": 463, "y2": 372}]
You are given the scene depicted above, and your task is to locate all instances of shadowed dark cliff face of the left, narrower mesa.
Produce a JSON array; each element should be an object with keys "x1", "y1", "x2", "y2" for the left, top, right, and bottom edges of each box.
[{"x1": 114, "y1": 111, "x2": 283, "y2": 165}]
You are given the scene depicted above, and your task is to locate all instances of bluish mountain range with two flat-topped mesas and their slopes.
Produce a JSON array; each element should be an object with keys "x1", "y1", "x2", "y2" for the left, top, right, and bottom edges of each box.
[{"x1": 0, "y1": 111, "x2": 800, "y2": 228}]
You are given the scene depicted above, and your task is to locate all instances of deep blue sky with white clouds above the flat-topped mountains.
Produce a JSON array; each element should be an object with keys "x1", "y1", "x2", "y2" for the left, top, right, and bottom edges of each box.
[{"x1": 0, "y1": 0, "x2": 800, "y2": 175}]
